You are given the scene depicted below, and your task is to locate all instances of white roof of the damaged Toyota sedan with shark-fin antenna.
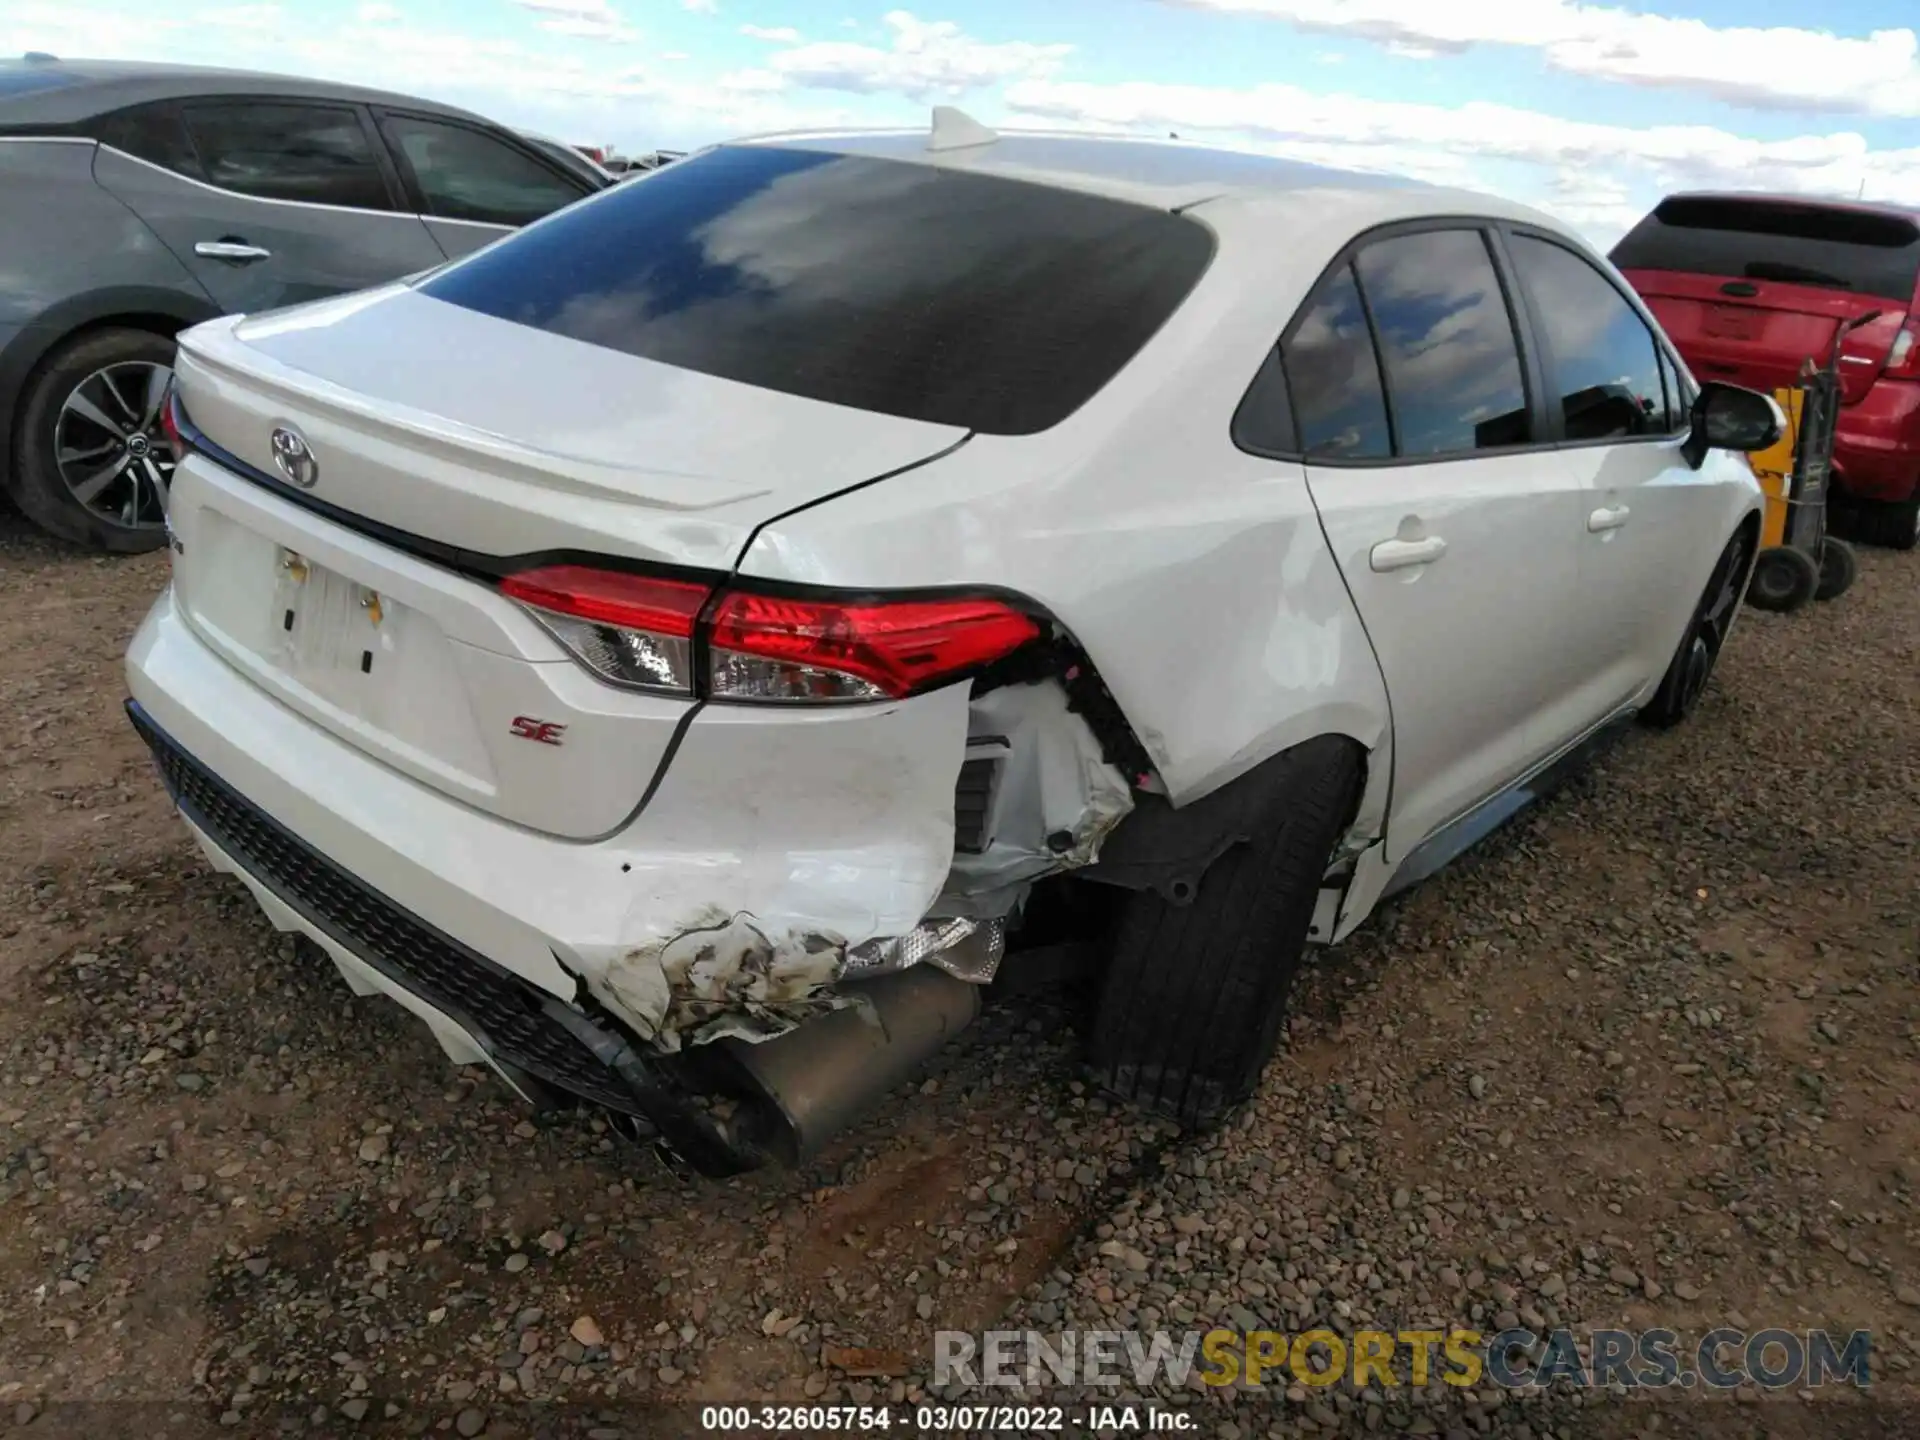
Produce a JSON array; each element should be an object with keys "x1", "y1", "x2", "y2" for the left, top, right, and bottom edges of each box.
[{"x1": 735, "y1": 117, "x2": 1565, "y2": 230}]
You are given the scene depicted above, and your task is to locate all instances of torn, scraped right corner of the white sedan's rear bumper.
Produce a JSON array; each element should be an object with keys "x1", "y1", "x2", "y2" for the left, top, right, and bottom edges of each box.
[{"x1": 563, "y1": 684, "x2": 968, "y2": 1050}]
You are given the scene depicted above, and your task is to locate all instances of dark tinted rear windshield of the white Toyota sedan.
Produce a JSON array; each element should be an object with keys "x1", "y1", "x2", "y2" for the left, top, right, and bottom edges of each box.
[{"x1": 420, "y1": 146, "x2": 1213, "y2": 436}]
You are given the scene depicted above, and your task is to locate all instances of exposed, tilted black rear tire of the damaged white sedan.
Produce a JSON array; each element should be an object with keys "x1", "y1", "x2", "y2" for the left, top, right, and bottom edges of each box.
[{"x1": 1089, "y1": 735, "x2": 1361, "y2": 1129}]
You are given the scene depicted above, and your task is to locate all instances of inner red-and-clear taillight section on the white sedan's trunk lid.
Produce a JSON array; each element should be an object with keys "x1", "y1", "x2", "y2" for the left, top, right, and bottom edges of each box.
[{"x1": 499, "y1": 564, "x2": 708, "y2": 695}]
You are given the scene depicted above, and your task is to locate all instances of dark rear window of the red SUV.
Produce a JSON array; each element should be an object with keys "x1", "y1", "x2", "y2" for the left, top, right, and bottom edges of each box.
[{"x1": 1613, "y1": 196, "x2": 1920, "y2": 303}]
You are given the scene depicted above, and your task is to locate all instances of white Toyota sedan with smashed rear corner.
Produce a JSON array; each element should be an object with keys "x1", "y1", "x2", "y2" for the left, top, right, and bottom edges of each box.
[{"x1": 127, "y1": 111, "x2": 1782, "y2": 1173}]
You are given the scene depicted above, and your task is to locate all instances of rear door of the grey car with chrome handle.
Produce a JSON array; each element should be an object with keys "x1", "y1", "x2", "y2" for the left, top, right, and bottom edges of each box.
[{"x1": 94, "y1": 98, "x2": 445, "y2": 313}]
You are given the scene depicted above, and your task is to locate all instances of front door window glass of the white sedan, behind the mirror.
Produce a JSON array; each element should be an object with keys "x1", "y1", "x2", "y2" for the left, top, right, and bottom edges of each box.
[{"x1": 1513, "y1": 234, "x2": 1667, "y2": 440}]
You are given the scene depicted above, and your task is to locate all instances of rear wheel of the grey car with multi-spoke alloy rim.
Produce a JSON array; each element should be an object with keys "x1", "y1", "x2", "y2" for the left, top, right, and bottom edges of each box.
[{"x1": 10, "y1": 326, "x2": 173, "y2": 555}]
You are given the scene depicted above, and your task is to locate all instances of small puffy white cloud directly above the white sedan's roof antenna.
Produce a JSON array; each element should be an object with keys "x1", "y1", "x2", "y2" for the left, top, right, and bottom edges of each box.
[{"x1": 768, "y1": 10, "x2": 1073, "y2": 100}]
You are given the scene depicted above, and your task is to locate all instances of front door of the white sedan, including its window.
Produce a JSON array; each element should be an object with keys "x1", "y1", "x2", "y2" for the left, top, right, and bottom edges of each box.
[{"x1": 1505, "y1": 228, "x2": 1726, "y2": 708}]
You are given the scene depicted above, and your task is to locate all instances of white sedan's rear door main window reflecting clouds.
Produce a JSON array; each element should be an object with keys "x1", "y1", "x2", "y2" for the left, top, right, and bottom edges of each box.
[{"x1": 1359, "y1": 230, "x2": 1530, "y2": 455}]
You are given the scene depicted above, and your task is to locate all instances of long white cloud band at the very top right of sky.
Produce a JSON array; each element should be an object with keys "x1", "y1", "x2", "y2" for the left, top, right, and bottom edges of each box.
[{"x1": 1167, "y1": 0, "x2": 1920, "y2": 115}]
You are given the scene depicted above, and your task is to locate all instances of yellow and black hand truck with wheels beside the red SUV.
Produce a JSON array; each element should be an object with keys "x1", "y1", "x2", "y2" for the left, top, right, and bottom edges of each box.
[{"x1": 1747, "y1": 309, "x2": 1880, "y2": 614}]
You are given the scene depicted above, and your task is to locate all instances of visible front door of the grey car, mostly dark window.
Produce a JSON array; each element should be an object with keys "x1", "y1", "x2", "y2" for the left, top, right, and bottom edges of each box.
[{"x1": 378, "y1": 109, "x2": 591, "y2": 257}]
